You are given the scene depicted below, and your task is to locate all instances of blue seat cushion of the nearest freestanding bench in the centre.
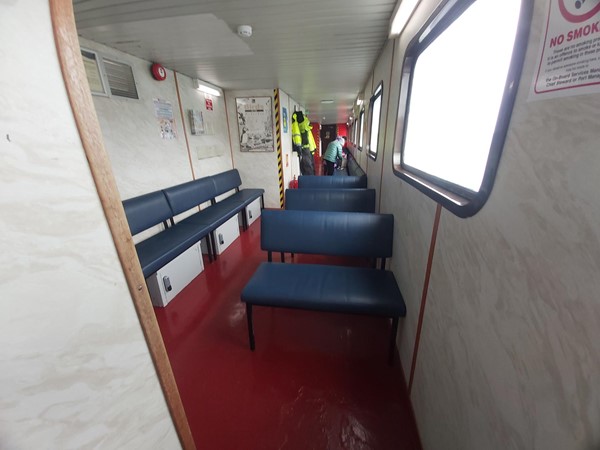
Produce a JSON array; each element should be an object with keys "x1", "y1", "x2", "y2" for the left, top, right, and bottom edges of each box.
[{"x1": 241, "y1": 263, "x2": 406, "y2": 317}]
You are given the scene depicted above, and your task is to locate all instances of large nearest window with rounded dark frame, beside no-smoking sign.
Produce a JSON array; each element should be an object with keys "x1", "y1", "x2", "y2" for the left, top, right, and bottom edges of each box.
[{"x1": 394, "y1": 0, "x2": 533, "y2": 217}]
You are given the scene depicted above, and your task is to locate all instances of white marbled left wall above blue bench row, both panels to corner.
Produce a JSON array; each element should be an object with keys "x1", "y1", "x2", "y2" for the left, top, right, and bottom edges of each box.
[{"x1": 80, "y1": 38, "x2": 233, "y2": 199}]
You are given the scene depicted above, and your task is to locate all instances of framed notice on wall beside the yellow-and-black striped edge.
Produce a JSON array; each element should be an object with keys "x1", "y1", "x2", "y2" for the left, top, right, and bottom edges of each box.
[{"x1": 235, "y1": 97, "x2": 274, "y2": 152}]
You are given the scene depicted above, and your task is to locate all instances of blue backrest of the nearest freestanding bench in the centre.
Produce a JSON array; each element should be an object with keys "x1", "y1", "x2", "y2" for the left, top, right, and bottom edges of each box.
[{"x1": 260, "y1": 209, "x2": 394, "y2": 258}]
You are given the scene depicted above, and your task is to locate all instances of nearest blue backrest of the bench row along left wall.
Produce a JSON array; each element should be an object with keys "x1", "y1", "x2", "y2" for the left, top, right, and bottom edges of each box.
[{"x1": 123, "y1": 191, "x2": 172, "y2": 235}]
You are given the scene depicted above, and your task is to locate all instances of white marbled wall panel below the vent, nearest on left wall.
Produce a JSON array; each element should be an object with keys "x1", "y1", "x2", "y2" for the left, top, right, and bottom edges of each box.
[{"x1": 80, "y1": 39, "x2": 192, "y2": 199}]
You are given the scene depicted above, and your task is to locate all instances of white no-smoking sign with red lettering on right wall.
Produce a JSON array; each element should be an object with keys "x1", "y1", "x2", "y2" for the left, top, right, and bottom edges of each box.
[{"x1": 529, "y1": 0, "x2": 600, "y2": 100}]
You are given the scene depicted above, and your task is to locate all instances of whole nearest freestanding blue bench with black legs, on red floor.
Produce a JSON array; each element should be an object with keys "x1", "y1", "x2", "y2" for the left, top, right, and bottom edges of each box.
[{"x1": 241, "y1": 210, "x2": 406, "y2": 364}]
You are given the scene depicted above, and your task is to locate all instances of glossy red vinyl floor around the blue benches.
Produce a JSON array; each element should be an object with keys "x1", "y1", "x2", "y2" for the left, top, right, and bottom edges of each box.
[{"x1": 155, "y1": 219, "x2": 421, "y2": 450}]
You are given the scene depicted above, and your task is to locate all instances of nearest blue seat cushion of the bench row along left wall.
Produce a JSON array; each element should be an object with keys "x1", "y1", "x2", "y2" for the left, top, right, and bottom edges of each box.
[{"x1": 135, "y1": 224, "x2": 211, "y2": 278}]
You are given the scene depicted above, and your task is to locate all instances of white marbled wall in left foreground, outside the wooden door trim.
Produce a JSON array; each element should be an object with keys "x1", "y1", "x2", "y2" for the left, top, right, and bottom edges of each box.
[{"x1": 0, "y1": 0, "x2": 180, "y2": 450}]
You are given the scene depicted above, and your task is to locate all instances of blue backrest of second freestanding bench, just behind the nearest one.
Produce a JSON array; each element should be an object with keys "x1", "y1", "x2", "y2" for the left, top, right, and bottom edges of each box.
[{"x1": 285, "y1": 188, "x2": 375, "y2": 213}]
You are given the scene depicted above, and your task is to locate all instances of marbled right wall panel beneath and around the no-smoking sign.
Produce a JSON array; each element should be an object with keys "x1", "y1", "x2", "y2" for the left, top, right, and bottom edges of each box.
[{"x1": 412, "y1": 1, "x2": 600, "y2": 450}]
